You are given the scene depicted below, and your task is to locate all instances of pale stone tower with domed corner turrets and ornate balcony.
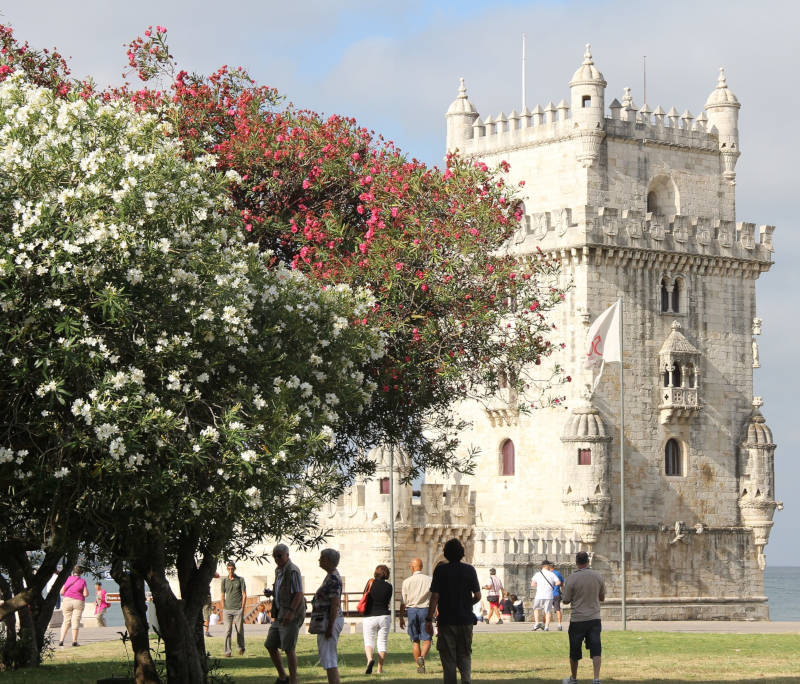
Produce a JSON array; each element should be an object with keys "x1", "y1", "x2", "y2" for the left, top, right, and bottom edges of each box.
[{"x1": 434, "y1": 46, "x2": 780, "y2": 619}]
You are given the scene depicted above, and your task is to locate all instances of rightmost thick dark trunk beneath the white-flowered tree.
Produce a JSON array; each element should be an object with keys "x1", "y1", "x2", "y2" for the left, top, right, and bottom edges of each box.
[{"x1": 147, "y1": 553, "x2": 207, "y2": 684}]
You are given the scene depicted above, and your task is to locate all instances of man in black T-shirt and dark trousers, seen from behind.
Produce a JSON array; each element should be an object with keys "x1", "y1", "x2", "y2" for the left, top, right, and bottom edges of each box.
[{"x1": 425, "y1": 539, "x2": 481, "y2": 684}]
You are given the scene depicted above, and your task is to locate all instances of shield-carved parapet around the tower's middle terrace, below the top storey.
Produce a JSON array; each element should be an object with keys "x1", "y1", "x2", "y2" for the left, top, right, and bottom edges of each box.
[{"x1": 512, "y1": 206, "x2": 775, "y2": 271}]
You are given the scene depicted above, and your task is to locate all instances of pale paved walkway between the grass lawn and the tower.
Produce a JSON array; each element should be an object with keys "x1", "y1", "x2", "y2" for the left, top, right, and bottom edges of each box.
[{"x1": 53, "y1": 618, "x2": 800, "y2": 648}]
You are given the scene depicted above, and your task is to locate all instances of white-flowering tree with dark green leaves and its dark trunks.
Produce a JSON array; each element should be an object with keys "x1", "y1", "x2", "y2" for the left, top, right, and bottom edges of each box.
[{"x1": 0, "y1": 73, "x2": 384, "y2": 682}]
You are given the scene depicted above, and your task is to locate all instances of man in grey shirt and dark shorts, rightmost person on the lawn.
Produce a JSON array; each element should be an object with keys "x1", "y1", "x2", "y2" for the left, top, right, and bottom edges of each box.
[{"x1": 561, "y1": 551, "x2": 606, "y2": 684}]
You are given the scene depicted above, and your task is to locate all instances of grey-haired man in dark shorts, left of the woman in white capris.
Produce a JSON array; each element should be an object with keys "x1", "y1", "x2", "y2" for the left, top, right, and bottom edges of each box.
[{"x1": 264, "y1": 544, "x2": 306, "y2": 684}]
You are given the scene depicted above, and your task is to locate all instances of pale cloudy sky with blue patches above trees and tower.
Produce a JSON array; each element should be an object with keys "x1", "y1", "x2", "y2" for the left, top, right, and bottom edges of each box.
[{"x1": 0, "y1": 0, "x2": 800, "y2": 566}]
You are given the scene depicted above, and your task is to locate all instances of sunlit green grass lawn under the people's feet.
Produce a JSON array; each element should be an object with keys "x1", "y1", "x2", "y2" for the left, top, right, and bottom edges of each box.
[{"x1": 0, "y1": 631, "x2": 800, "y2": 684}]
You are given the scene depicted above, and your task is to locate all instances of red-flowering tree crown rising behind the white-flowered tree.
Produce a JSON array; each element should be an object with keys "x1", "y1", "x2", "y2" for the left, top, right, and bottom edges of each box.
[{"x1": 126, "y1": 27, "x2": 563, "y2": 476}]
